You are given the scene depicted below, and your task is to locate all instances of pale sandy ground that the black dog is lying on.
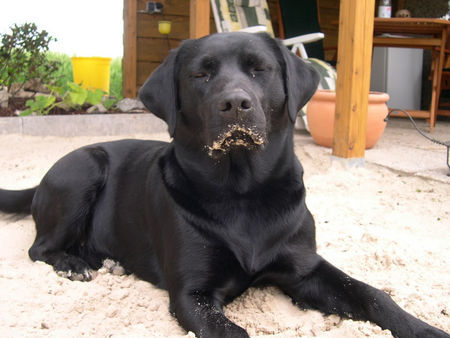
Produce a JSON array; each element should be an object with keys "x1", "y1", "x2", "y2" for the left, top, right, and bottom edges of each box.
[{"x1": 0, "y1": 120, "x2": 450, "y2": 337}]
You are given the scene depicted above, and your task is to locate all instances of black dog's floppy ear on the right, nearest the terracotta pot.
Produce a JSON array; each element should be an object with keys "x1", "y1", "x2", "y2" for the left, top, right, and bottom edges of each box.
[{"x1": 278, "y1": 41, "x2": 320, "y2": 122}]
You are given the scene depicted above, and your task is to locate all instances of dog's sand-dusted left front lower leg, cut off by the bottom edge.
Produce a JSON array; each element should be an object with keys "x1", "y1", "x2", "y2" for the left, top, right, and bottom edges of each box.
[{"x1": 171, "y1": 292, "x2": 249, "y2": 338}]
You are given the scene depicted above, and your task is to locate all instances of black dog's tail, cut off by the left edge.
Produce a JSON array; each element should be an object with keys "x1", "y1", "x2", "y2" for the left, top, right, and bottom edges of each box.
[{"x1": 0, "y1": 187, "x2": 37, "y2": 215}]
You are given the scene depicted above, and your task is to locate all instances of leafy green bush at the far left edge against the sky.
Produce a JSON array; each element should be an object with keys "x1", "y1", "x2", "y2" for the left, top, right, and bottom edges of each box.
[{"x1": 0, "y1": 23, "x2": 59, "y2": 96}]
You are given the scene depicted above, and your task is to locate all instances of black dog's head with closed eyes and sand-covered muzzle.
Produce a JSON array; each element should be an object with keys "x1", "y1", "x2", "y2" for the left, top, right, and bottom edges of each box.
[{"x1": 139, "y1": 33, "x2": 318, "y2": 157}]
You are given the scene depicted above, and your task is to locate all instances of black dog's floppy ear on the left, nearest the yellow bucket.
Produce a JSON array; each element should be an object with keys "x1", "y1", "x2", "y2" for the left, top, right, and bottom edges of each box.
[{"x1": 139, "y1": 49, "x2": 179, "y2": 136}]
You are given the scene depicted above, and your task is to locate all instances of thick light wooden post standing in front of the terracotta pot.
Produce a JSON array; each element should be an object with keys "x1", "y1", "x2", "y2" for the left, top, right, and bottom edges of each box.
[{"x1": 333, "y1": 0, "x2": 375, "y2": 158}]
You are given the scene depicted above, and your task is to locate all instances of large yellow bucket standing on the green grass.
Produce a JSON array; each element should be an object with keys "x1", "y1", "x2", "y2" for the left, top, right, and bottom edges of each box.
[{"x1": 72, "y1": 57, "x2": 111, "y2": 93}]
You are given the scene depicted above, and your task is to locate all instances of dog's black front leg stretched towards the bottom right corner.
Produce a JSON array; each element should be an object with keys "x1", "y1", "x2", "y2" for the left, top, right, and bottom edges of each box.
[{"x1": 280, "y1": 259, "x2": 449, "y2": 338}]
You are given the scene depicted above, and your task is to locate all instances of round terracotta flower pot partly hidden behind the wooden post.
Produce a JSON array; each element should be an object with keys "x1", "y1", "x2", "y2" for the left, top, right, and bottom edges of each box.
[{"x1": 306, "y1": 89, "x2": 389, "y2": 149}]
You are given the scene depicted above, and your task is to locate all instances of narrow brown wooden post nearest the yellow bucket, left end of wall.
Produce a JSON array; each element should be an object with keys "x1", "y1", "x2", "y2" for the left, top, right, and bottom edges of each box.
[{"x1": 122, "y1": 0, "x2": 137, "y2": 98}]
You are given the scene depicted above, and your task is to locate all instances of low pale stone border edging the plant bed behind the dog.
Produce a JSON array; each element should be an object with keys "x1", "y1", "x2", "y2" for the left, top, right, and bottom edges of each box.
[{"x1": 0, "y1": 113, "x2": 167, "y2": 137}]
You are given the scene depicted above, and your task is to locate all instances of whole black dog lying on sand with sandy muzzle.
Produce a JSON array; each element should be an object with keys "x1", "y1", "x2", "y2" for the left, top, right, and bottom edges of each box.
[{"x1": 0, "y1": 33, "x2": 448, "y2": 337}]
